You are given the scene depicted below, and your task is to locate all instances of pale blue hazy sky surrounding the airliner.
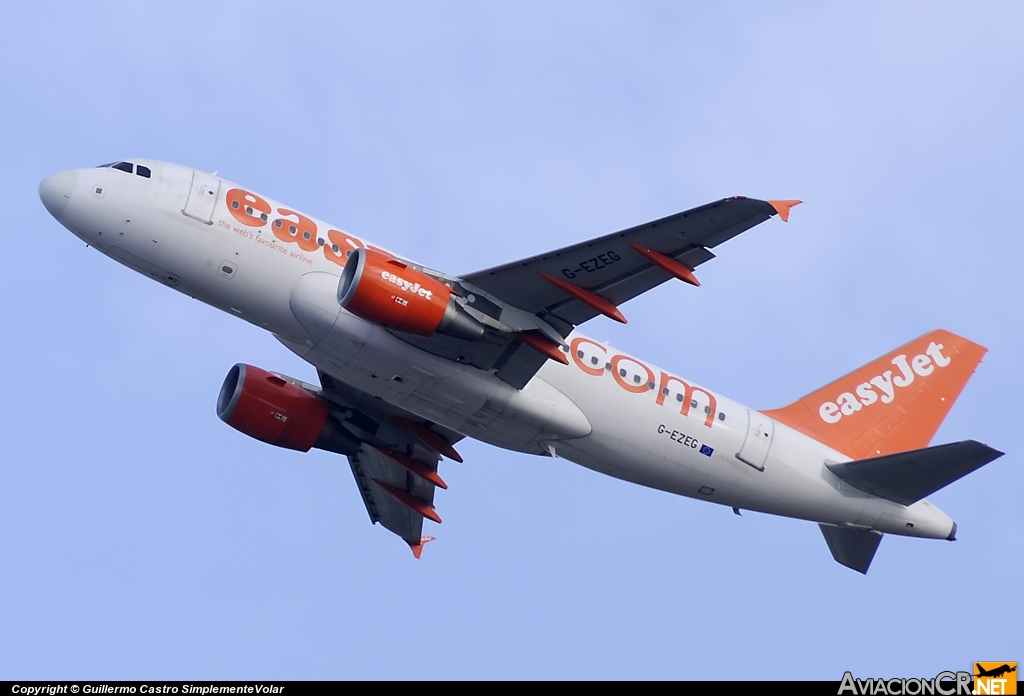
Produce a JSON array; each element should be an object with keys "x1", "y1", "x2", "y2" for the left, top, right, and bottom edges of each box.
[{"x1": 0, "y1": 2, "x2": 1024, "y2": 680}]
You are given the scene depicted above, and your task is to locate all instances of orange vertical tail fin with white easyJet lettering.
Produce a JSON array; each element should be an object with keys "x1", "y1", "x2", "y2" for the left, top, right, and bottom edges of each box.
[{"x1": 764, "y1": 329, "x2": 987, "y2": 460}]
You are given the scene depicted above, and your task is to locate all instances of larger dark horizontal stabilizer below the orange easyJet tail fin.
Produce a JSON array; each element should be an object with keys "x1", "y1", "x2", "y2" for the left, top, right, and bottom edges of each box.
[{"x1": 825, "y1": 440, "x2": 1002, "y2": 505}]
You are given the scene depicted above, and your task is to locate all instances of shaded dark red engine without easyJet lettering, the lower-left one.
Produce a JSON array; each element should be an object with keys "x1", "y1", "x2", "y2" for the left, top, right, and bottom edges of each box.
[{"x1": 217, "y1": 363, "x2": 360, "y2": 455}]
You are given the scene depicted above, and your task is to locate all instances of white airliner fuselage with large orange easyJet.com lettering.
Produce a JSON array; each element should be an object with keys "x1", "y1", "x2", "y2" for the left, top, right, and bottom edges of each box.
[{"x1": 44, "y1": 160, "x2": 953, "y2": 538}]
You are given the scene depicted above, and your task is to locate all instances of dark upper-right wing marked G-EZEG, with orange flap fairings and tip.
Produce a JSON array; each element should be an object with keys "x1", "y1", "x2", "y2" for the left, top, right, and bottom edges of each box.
[{"x1": 395, "y1": 197, "x2": 800, "y2": 389}]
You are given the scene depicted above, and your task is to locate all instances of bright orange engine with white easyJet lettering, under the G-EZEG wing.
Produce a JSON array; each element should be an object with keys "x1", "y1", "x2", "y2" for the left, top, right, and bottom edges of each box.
[{"x1": 338, "y1": 249, "x2": 483, "y2": 340}]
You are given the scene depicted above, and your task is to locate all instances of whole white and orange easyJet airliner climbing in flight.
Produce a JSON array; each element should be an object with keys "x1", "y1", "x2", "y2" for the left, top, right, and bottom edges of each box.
[{"x1": 39, "y1": 160, "x2": 1002, "y2": 574}]
